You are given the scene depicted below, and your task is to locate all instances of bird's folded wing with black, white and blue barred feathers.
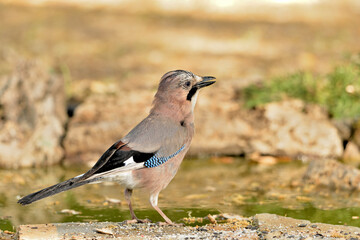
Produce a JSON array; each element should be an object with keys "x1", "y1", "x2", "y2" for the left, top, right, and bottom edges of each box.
[{"x1": 79, "y1": 116, "x2": 185, "y2": 180}]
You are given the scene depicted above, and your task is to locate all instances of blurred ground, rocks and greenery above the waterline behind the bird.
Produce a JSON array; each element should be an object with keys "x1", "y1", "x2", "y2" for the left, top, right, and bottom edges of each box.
[{"x1": 0, "y1": 0, "x2": 360, "y2": 168}]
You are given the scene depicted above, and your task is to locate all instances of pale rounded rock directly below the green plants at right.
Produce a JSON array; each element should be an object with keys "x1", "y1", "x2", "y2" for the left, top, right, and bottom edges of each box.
[{"x1": 252, "y1": 100, "x2": 343, "y2": 158}]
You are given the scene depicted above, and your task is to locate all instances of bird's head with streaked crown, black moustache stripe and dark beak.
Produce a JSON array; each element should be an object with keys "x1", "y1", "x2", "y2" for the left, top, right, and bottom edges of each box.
[{"x1": 154, "y1": 70, "x2": 215, "y2": 113}]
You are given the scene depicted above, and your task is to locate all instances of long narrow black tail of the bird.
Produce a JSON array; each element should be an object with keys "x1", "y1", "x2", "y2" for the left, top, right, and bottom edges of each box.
[{"x1": 18, "y1": 177, "x2": 95, "y2": 205}]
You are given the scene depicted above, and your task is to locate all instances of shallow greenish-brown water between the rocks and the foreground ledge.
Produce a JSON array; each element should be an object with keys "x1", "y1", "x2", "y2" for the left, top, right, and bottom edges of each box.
[{"x1": 0, "y1": 158, "x2": 360, "y2": 231}]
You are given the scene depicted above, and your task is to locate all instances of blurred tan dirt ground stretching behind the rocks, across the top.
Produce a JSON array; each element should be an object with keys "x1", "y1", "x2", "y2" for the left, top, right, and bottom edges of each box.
[{"x1": 0, "y1": 1, "x2": 360, "y2": 100}]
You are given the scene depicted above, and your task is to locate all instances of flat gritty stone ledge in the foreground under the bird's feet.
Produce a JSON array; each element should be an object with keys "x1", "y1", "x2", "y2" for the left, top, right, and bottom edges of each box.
[{"x1": 17, "y1": 213, "x2": 360, "y2": 240}]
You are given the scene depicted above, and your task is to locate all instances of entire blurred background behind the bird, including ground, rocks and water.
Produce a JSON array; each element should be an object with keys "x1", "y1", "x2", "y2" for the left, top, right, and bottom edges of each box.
[{"x1": 0, "y1": 0, "x2": 360, "y2": 235}]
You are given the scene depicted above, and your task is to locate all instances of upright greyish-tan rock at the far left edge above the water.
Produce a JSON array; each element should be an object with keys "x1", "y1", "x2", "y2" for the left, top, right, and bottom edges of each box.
[{"x1": 0, "y1": 61, "x2": 66, "y2": 168}]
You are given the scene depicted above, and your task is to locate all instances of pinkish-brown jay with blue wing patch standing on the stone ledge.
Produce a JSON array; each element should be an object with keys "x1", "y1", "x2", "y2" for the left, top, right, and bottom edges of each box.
[{"x1": 18, "y1": 70, "x2": 216, "y2": 224}]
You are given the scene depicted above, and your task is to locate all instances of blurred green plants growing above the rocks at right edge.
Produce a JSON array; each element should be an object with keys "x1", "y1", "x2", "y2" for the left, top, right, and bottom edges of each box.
[{"x1": 241, "y1": 61, "x2": 360, "y2": 119}]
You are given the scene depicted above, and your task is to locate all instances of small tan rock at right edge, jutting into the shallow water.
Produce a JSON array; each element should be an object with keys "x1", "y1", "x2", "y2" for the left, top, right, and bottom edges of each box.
[{"x1": 304, "y1": 160, "x2": 360, "y2": 191}]
